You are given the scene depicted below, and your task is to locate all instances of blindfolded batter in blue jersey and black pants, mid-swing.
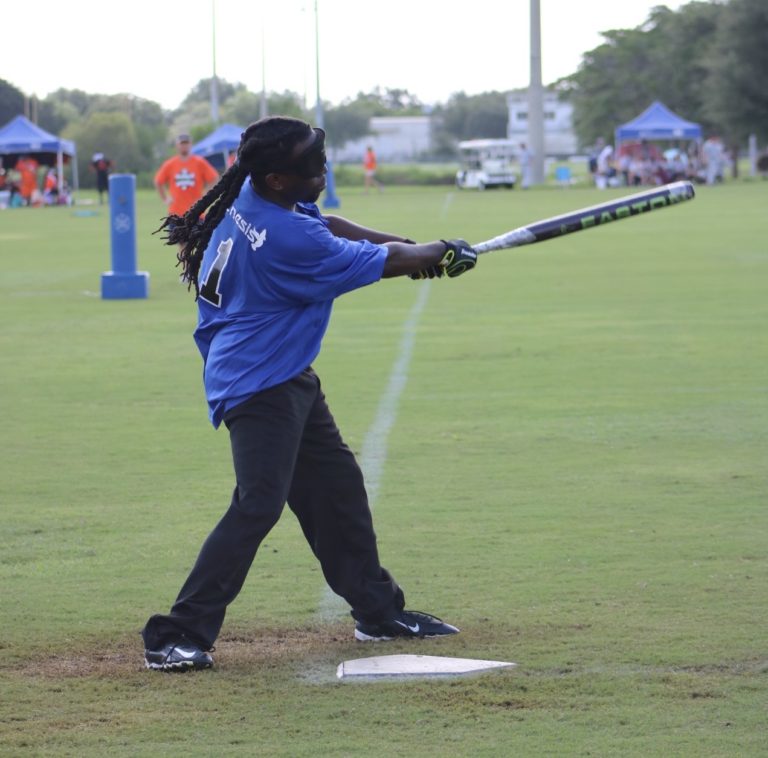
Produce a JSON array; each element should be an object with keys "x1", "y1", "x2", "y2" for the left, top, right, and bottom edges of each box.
[{"x1": 142, "y1": 116, "x2": 477, "y2": 671}]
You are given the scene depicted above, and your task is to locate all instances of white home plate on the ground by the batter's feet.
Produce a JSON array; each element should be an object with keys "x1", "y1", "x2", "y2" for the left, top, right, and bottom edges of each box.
[{"x1": 336, "y1": 655, "x2": 517, "y2": 679}]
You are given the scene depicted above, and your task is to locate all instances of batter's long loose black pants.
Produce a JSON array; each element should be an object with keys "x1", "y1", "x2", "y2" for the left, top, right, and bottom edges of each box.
[{"x1": 142, "y1": 368, "x2": 404, "y2": 650}]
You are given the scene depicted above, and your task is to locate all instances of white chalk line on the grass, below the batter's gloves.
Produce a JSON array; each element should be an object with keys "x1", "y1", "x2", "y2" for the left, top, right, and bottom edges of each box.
[{"x1": 316, "y1": 281, "x2": 430, "y2": 621}]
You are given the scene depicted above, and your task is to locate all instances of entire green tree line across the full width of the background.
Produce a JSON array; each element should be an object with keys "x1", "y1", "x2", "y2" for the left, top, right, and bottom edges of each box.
[{"x1": 0, "y1": 0, "x2": 768, "y2": 186}]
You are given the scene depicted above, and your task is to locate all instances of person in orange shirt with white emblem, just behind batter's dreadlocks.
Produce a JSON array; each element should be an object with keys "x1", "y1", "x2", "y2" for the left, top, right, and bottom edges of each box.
[{"x1": 155, "y1": 134, "x2": 219, "y2": 216}]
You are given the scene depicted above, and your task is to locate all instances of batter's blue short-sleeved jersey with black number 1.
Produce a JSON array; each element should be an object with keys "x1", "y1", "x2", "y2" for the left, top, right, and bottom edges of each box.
[{"x1": 194, "y1": 180, "x2": 387, "y2": 427}]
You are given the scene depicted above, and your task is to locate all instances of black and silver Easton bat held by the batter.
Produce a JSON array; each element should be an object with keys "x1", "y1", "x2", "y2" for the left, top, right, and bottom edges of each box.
[{"x1": 472, "y1": 182, "x2": 695, "y2": 253}]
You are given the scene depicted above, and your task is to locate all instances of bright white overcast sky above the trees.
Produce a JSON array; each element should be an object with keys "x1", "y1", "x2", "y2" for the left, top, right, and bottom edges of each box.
[{"x1": 6, "y1": 0, "x2": 685, "y2": 109}]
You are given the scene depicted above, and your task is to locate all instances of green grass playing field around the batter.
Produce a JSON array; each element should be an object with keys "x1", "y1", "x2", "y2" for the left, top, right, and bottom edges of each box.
[{"x1": 0, "y1": 182, "x2": 768, "y2": 758}]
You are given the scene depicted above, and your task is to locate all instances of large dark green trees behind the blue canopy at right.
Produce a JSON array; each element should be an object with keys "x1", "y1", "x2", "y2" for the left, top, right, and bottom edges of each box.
[{"x1": 554, "y1": 0, "x2": 768, "y2": 147}]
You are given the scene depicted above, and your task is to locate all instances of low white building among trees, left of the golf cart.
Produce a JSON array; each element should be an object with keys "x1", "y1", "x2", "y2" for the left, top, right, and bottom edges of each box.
[{"x1": 332, "y1": 116, "x2": 432, "y2": 163}]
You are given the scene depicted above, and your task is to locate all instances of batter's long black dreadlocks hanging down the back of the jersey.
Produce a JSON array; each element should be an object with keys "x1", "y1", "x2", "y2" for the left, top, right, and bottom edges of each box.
[{"x1": 155, "y1": 116, "x2": 312, "y2": 300}]
